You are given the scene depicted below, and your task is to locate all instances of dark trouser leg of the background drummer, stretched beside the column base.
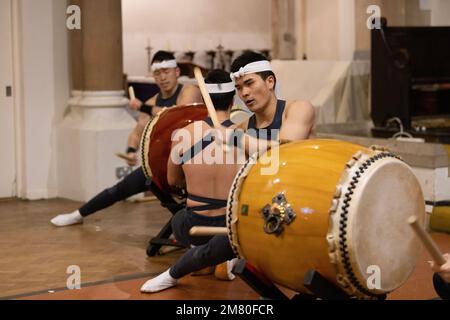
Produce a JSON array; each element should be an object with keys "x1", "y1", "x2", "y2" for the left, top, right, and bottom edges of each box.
[{"x1": 79, "y1": 167, "x2": 151, "y2": 217}]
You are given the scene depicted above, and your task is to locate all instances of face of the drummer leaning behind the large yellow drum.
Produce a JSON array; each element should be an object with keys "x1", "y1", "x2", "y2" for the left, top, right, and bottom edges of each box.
[{"x1": 236, "y1": 73, "x2": 274, "y2": 112}]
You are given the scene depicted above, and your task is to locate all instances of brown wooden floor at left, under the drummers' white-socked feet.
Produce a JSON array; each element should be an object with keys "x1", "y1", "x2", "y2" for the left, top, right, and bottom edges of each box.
[{"x1": 0, "y1": 199, "x2": 182, "y2": 297}]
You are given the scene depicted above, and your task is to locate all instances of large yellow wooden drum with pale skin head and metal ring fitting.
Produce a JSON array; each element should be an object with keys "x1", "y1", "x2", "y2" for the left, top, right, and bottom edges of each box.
[{"x1": 227, "y1": 140, "x2": 425, "y2": 299}]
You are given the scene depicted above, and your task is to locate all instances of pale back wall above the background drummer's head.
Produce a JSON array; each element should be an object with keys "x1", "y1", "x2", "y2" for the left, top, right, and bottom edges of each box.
[{"x1": 122, "y1": 0, "x2": 271, "y2": 75}]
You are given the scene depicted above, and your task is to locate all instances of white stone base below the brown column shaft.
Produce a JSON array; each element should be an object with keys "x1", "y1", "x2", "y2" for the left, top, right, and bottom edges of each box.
[{"x1": 57, "y1": 91, "x2": 136, "y2": 202}]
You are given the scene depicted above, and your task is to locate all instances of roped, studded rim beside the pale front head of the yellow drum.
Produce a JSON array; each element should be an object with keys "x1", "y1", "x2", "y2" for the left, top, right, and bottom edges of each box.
[{"x1": 326, "y1": 146, "x2": 404, "y2": 298}]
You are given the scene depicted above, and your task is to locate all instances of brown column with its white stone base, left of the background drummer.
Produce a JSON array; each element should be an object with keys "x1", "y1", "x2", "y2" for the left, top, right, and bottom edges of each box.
[{"x1": 58, "y1": 0, "x2": 136, "y2": 201}]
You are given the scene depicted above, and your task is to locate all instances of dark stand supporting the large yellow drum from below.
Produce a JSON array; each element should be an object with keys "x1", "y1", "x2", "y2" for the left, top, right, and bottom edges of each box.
[{"x1": 233, "y1": 260, "x2": 386, "y2": 300}]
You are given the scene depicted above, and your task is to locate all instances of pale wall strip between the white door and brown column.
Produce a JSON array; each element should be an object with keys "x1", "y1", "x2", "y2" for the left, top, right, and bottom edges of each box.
[{"x1": 15, "y1": 0, "x2": 69, "y2": 199}]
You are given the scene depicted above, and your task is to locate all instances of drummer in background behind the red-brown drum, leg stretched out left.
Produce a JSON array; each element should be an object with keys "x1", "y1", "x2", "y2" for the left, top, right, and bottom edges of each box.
[{"x1": 51, "y1": 51, "x2": 202, "y2": 227}]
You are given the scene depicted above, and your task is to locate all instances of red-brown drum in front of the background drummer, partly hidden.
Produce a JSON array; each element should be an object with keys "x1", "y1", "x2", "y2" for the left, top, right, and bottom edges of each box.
[{"x1": 141, "y1": 103, "x2": 208, "y2": 193}]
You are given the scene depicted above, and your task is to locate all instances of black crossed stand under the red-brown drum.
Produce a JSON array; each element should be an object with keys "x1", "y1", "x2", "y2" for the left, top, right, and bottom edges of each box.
[{"x1": 147, "y1": 183, "x2": 185, "y2": 257}]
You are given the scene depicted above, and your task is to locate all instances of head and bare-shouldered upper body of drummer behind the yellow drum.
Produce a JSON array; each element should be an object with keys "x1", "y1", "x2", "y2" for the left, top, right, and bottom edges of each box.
[{"x1": 224, "y1": 51, "x2": 314, "y2": 150}]
